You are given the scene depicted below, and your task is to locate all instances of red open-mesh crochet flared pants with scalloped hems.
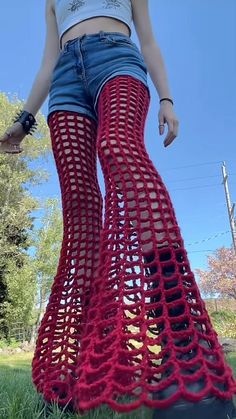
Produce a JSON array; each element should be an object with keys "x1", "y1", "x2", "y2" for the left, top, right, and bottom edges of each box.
[{"x1": 32, "y1": 76, "x2": 235, "y2": 412}]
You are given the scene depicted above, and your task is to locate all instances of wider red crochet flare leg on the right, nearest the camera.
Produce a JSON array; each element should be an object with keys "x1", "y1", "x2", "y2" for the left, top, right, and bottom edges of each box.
[{"x1": 73, "y1": 76, "x2": 234, "y2": 417}]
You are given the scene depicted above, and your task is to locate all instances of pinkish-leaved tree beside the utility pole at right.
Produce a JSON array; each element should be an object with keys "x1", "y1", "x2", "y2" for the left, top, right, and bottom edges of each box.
[{"x1": 196, "y1": 247, "x2": 236, "y2": 300}]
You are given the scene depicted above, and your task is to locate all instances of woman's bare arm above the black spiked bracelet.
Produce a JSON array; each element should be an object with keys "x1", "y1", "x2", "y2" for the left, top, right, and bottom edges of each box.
[{"x1": 24, "y1": 0, "x2": 60, "y2": 116}]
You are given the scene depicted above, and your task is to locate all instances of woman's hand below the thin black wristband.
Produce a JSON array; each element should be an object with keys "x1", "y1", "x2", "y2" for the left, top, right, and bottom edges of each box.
[{"x1": 158, "y1": 100, "x2": 179, "y2": 147}]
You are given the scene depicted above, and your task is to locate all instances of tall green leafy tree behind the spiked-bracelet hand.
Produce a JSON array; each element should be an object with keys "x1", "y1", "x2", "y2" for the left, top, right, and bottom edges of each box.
[{"x1": 0, "y1": 92, "x2": 51, "y2": 337}]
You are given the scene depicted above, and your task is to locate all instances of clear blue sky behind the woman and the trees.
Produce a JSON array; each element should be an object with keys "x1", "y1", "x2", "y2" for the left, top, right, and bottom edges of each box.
[{"x1": 0, "y1": 0, "x2": 236, "y2": 269}]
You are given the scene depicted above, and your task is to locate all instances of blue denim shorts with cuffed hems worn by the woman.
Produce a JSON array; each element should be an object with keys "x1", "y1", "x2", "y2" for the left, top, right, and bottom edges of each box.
[{"x1": 47, "y1": 31, "x2": 150, "y2": 122}]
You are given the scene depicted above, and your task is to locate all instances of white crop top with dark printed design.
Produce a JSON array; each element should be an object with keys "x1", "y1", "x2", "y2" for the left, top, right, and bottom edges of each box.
[{"x1": 55, "y1": 0, "x2": 132, "y2": 43}]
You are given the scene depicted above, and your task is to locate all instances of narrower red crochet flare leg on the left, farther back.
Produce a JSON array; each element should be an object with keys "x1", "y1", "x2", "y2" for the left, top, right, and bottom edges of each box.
[{"x1": 32, "y1": 111, "x2": 102, "y2": 406}]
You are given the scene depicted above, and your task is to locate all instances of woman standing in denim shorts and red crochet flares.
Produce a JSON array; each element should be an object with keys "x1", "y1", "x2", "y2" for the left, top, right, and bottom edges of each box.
[{"x1": 0, "y1": 0, "x2": 235, "y2": 419}]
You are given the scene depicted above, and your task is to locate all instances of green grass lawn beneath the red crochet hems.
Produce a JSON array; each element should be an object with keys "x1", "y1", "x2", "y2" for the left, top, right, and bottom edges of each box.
[{"x1": 0, "y1": 353, "x2": 236, "y2": 419}]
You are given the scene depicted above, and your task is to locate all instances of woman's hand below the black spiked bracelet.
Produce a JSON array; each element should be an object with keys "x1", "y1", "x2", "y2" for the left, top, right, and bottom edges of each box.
[{"x1": 0, "y1": 122, "x2": 26, "y2": 154}]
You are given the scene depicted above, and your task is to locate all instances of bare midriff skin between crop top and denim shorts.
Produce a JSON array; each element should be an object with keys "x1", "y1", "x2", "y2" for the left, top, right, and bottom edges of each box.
[{"x1": 61, "y1": 16, "x2": 130, "y2": 49}]
